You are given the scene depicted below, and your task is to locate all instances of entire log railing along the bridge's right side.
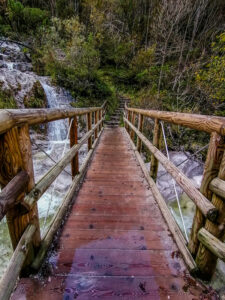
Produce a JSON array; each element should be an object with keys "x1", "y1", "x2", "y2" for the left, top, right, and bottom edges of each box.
[{"x1": 124, "y1": 106, "x2": 225, "y2": 280}]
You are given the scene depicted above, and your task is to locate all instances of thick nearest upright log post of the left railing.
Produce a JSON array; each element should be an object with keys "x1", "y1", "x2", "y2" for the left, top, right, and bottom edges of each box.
[{"x1": 0, "y1": 125, "x2": 41, "y2": 255}]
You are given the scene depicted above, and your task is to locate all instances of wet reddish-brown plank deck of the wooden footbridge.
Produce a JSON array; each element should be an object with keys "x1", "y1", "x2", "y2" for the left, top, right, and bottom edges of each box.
[{"x1": 12, "y1": 128, "x2": 211, "y2": 300}]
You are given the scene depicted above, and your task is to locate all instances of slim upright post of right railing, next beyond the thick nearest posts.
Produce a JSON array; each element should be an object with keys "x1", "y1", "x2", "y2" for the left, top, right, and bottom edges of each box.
[{"x1": 150, "y1": 119, "x2": 162, "y2": 181}]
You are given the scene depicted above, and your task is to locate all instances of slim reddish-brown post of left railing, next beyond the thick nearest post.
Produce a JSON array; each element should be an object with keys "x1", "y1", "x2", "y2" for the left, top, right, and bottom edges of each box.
[{"x1": 70, "y1": 116, "x2": 79, "y2": 178}]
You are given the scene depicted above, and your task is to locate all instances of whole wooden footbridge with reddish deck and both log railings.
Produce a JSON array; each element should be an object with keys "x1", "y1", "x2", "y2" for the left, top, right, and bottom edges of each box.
[{"x1": 0, "y1": 104, "x2": 225, "y2": 300}]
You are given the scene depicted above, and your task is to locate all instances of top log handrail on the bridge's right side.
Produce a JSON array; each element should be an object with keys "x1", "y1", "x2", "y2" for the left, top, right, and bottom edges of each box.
[{"x1": 125, "y1": 106, "x2": 225, "y2": 136}]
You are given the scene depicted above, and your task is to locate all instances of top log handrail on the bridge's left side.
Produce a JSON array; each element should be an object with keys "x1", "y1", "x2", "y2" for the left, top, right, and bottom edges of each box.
[{"x1": 0, "y1": 102, "x2": 106, "y2": 134}]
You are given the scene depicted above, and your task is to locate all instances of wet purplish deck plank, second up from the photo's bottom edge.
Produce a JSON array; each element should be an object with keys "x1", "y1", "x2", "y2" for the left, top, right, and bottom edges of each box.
[{"x1": 54, "y1": 249, "x2": 185, "y2": 276}]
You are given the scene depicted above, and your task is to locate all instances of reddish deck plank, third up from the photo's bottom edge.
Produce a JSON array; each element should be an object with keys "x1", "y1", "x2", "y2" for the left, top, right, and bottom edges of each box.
[{"x1": 60, "y1": 230, "x2": 176, "y2": 251}]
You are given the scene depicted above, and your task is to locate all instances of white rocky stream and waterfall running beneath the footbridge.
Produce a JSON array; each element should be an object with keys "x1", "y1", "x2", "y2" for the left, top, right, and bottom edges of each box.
[{"x1": 0, "y1": 43, "x2": 225, "y2": 296}]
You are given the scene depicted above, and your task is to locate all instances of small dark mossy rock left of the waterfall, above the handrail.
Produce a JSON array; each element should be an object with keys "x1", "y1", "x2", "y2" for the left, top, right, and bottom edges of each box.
[{"x1": 24, "y1": 81, "x2": 47, "y2": 108}]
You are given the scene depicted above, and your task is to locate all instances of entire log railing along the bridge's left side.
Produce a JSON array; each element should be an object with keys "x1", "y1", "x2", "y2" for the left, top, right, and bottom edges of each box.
[{"x1": 0, "y1": 103, "x2": 106, "y2": 300}]
